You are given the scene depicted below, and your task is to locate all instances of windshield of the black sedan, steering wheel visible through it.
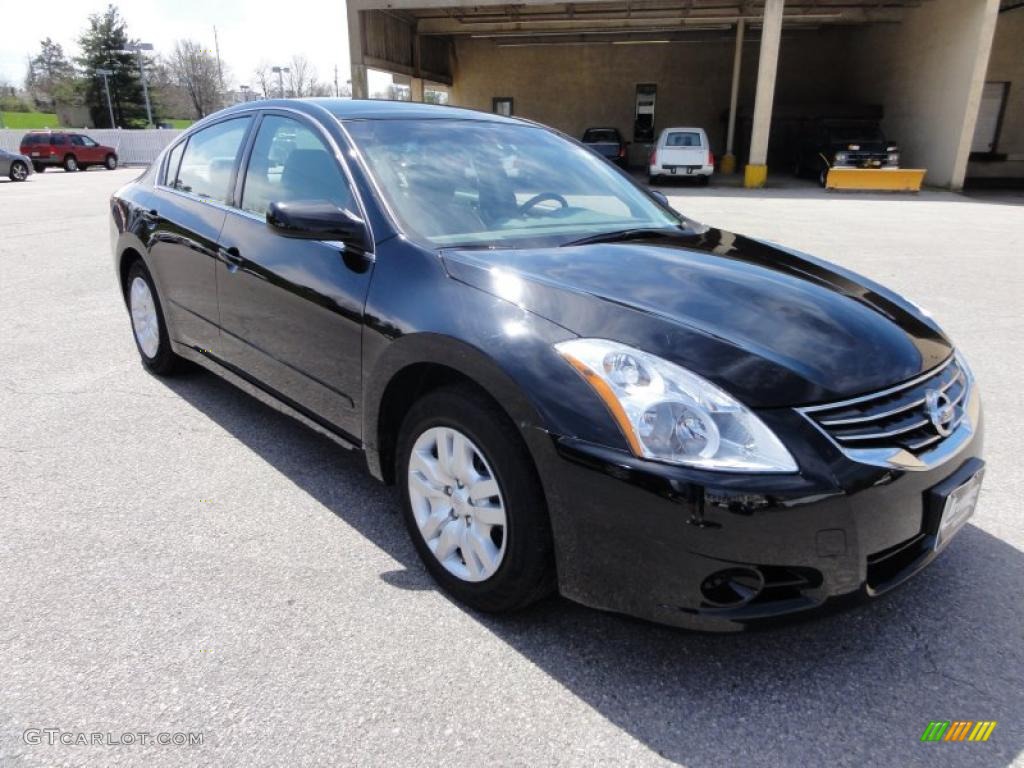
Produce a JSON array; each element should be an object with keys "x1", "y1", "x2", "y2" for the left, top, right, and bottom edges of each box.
[{"x1": 345, "y1": 120, "x2": 680, "y2": 248}]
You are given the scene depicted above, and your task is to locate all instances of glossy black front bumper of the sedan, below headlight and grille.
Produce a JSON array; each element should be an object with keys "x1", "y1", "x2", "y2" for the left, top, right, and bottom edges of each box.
[{"x1": 531, "y1": 403, "x2": 983, "y2": 631}]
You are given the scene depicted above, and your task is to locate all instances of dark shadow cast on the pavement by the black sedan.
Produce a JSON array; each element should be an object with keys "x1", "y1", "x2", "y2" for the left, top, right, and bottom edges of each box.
[{"x1": 162, "y1": 371, "x2": 1024, "y2": 768}]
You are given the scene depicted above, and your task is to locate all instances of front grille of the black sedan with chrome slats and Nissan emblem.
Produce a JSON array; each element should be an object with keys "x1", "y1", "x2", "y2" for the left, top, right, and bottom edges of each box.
[{"x1": 802, "y1": 357, "x2": 971, "y2": 456}]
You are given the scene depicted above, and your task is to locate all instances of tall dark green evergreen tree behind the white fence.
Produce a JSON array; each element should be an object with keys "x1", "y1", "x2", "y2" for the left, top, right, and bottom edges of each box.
[{"x1": 77, "y1": 5, "x2": 145, "y2": 128}]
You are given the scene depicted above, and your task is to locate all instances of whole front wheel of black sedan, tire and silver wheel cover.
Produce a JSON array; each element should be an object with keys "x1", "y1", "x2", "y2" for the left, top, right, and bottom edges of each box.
[{"x1": 396, "y1": 387, "x2": 555, "y2": 612}]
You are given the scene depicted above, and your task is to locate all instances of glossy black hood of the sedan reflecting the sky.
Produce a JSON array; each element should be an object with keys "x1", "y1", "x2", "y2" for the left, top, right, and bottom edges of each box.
[{"x1": 441, "y1": 227, "x2": 952, "y2": 408}]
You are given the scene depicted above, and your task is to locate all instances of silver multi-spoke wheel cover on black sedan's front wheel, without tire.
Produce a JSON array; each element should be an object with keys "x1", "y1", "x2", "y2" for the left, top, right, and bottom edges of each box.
[{"x1": 408, "y1": 427, "x2": 507, "y2": 582}]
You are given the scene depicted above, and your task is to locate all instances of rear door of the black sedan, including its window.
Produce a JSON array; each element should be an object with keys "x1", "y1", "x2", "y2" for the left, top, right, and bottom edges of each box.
[{"x1": 145, "y1": 116, "x2": 253, "y2": 354}]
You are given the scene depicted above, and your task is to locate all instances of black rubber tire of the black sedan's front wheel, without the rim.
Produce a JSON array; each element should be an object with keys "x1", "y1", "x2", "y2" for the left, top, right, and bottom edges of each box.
[{"x1": 395, "y1": 386, "x2": 555, "y2": 613}]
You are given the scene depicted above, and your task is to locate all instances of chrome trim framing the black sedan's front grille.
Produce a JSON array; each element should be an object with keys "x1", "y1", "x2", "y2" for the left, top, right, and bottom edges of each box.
[{"x1": 795, "y1": 352, "x2": 981, "y2": 472}]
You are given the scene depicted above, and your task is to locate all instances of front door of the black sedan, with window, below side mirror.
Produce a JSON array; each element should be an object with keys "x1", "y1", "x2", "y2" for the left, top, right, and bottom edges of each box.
[{"x1": 217, "y1": 112, "x2": 373, "y2": 438}]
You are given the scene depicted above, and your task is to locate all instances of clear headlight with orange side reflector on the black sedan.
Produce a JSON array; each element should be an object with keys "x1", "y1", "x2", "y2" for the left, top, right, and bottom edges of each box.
[{"x1": 555, "y1": 339, "x2": 797, "y2": 472}]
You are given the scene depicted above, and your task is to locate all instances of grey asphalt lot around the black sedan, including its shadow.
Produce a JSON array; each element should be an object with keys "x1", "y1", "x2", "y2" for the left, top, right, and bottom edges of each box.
[{"x1": 0, "y1": 169, "x2": 1024, "y2": 768}]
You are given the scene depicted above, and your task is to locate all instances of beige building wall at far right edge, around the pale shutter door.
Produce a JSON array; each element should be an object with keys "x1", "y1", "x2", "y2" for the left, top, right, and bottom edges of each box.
[{"x1": 968, "y1": 8, "x2": 1024, "y2": 178}]
